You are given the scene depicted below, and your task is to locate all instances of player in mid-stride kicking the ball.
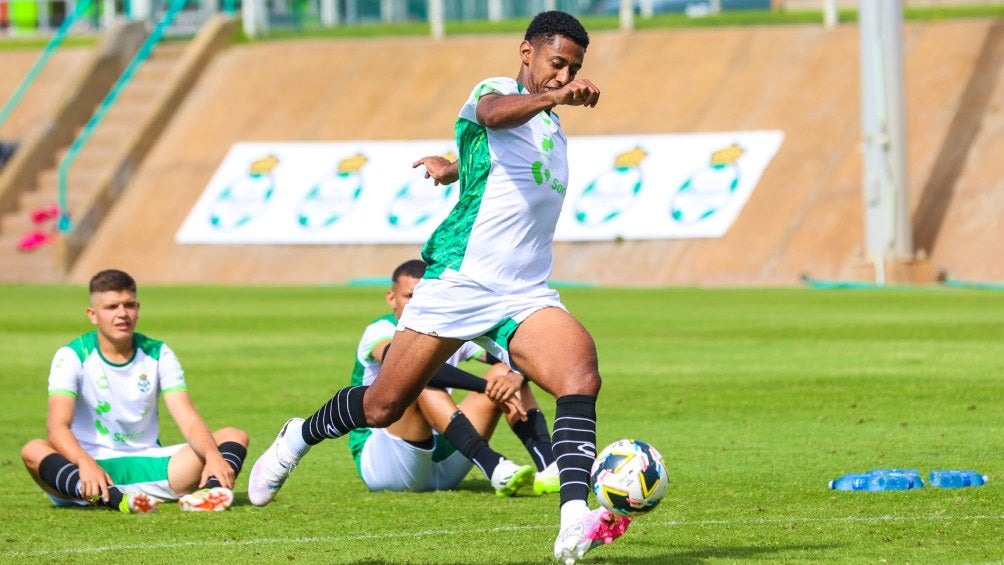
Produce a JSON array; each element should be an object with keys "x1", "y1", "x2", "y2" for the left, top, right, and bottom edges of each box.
[{"x1": 248, "y1": 11, "x2": 631, "y2": 564}]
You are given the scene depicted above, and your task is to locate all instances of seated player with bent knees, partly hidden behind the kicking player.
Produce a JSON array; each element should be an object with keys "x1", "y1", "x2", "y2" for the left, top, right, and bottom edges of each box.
[{"x1": 248, "y1": 260, "x2": 558, "y2": 504}]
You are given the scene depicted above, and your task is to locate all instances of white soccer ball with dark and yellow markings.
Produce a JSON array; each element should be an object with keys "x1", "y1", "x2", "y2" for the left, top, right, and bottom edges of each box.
[{"x1": 590, "y1": 440, "x2": 670, "y2": 516}]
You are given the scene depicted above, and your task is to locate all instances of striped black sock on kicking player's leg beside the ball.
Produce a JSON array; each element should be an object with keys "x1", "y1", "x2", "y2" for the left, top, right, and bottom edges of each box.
[{"x1": 553, "y1": 394, "x2": 596, "y2": 504}]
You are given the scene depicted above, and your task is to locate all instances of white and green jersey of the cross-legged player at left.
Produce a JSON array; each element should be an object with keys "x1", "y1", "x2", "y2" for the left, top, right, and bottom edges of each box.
[{"x1": 49, "y1": 331, "x2": 187, "y2": 456}]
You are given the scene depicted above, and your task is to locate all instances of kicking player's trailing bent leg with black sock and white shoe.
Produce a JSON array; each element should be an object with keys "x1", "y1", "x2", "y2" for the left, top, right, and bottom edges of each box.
[{"x1": 248, "y1": 329, "x2": 462, "y2": 506}]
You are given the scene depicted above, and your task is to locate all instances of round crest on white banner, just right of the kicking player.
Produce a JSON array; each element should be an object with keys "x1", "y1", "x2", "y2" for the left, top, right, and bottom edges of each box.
[{"x1": 575, "y1": 148, "x2": 649, "y2": 226}]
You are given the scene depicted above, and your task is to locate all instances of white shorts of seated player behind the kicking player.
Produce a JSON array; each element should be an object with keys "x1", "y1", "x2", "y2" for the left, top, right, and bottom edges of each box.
[{"x1": 359, "y1": 428, "x2": 474, "y2": 493}]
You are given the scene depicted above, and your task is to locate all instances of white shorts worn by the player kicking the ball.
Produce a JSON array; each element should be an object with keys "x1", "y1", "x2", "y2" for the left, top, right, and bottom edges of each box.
[{"x1": 398, "y1": 269, "x2": 565, "y2": 366}]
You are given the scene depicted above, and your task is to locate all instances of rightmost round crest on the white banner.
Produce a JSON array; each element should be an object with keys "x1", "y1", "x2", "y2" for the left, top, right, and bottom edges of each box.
[{"x1": 670, "y1": 144, "x2": 745, "y2": 224}]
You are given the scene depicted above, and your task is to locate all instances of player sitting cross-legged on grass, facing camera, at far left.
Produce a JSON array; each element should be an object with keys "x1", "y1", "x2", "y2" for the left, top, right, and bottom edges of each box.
[{"x1": 21, "y1": 270, "x2": 248, "y2": 513}]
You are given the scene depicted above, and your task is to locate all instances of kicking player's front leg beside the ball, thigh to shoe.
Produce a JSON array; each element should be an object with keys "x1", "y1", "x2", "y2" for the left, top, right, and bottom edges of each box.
[{"x1": 509, "y1": 307, "x2": 630, "y2": 563}]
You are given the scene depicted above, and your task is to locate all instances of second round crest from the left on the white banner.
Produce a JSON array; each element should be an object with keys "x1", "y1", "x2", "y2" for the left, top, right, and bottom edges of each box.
[{"x1": 296, "y1": 154, "x2": 368, "y2": 230}]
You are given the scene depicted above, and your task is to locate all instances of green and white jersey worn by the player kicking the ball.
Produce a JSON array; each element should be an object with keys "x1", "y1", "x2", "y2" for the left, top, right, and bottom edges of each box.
[{"x1": 422, "y1": 77, "x2": 568, "y2": 292}]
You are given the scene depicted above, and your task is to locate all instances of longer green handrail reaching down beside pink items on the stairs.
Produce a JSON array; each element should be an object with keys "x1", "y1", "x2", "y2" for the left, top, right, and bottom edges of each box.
[{"x1": 58, "y1": 0, "x2": 188, "y2": 234}]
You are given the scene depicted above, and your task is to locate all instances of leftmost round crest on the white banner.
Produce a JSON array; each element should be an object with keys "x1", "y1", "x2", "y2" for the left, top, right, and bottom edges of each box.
[{"x1": 209, "y1": 155, "x2": 279, "y2": 230}]
